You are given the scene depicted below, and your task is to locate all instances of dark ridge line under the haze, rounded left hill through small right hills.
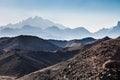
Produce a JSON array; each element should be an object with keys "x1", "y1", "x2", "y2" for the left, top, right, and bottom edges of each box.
[{"x1": 0, "y1": 35, "x2": 96, "y2": 53}]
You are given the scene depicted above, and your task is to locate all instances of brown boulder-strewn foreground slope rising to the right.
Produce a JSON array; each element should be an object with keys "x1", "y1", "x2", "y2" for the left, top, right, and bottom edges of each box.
[{"x1": 17, "y1": 37, "x2": 120, "y2": 80}]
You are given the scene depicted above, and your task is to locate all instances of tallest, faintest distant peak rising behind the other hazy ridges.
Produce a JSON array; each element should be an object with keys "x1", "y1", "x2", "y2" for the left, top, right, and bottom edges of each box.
[{"x1": 2, "y1": 16, "x2": 65, "y2": 29}]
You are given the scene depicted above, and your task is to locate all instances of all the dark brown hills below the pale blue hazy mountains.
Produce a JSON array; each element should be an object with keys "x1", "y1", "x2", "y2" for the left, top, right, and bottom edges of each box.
[{"x1": 0, "y1": 35, "x2": 120, "y2": 80}]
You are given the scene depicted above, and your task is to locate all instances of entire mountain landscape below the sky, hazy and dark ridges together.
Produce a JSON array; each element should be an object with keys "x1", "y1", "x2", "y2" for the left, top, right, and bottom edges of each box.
[{"x1": 0, "y1": 17, "x2": 120, "y2": 80}]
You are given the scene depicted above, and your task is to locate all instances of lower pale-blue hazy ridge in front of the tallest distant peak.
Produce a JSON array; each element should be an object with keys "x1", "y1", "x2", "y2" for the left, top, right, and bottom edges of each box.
[{"x1": 0, "y1": 25, "x2": 91, "y2": 40}]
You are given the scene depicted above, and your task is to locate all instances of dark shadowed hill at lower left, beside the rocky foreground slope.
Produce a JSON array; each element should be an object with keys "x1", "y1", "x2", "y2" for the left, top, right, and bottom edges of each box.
[{"x1": 0, "y1": 49, "x2": 77, "y2": 77}]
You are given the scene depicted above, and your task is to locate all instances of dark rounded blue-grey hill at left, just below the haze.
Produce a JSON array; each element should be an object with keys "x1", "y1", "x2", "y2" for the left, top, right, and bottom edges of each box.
[{"x1": 0, "y1": 35, "x2": 60, "y2": 51}]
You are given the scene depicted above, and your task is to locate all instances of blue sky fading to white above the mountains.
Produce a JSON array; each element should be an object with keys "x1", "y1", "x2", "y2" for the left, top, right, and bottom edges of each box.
[{"x1": 0, "y1": 0, "x2": 120, "y2": 32}]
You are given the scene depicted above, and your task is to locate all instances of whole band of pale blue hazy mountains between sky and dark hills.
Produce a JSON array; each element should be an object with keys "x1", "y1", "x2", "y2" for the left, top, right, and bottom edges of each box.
[{"x1": 0, "y1": 17, "x2": 120, "y2": 40}]
